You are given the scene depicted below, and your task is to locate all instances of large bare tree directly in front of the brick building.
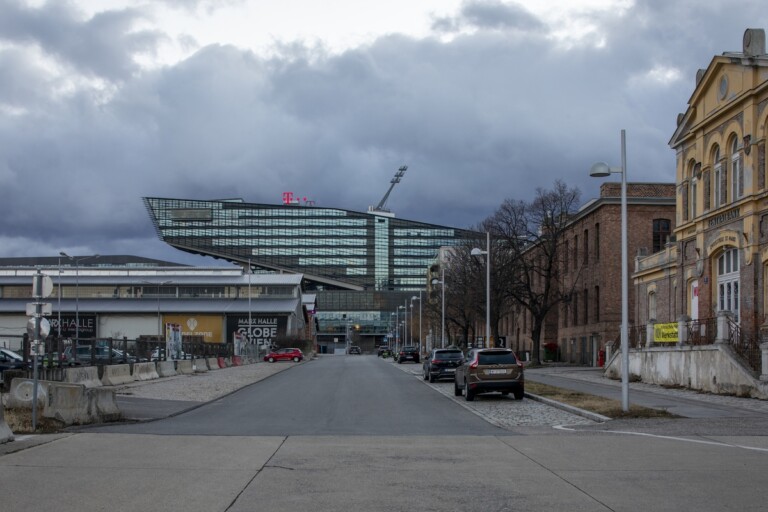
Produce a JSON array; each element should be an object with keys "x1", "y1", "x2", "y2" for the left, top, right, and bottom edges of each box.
[{"x1": 484, "y1": 180, "x2": 581, "y2": 363}]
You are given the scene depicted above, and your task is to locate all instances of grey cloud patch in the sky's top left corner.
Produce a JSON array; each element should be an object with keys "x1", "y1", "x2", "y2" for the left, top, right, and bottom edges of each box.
[{"x1": 0, "y1": 0, "x2": 163, "y2": 80}]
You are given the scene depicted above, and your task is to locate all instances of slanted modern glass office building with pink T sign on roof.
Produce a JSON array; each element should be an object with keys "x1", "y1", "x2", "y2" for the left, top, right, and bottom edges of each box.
[{"x1": 144, "y1": 197, "x2": 476, "y2": 343}]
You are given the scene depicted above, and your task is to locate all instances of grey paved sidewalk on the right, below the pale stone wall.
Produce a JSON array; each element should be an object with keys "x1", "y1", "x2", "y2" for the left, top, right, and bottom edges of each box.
[{"x1": 525, "y1": 366, "x2": 768, "y2": 418}]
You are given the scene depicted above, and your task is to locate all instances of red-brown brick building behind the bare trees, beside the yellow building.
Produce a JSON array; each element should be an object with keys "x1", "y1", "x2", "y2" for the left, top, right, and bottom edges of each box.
[{"x1": 501, "y1": 183, "x2": 675, "y2": 365}]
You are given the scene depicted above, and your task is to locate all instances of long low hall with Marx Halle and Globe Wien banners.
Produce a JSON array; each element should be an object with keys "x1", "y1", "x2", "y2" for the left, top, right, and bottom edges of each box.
[{"x1": 0, "y1": 256, "x2": 308, "y2": 348}]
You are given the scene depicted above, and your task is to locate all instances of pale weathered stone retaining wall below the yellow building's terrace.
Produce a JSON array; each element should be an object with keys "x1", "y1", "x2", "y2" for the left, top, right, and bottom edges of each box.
[{"x1": 604, "y1": 344, "x2": 768, "y2": 400}]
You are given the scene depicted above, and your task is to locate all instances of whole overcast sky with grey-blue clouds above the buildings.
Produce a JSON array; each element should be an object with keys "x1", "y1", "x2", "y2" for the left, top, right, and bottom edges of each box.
[{"x1": 0, "y1": 0, "x2": 768, "y2": 264}]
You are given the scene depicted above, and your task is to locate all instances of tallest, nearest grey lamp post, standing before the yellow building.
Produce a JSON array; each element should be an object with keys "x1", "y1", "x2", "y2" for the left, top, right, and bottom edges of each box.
[{"x1": 589, "y1": 130, "x2": 629, "y2": 412}]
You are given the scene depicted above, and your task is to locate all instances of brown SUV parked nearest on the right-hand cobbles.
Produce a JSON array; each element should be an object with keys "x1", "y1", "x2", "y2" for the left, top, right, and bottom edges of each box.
[{"x1": 453, "y1": 348, "x2": 525, "y2": 402}]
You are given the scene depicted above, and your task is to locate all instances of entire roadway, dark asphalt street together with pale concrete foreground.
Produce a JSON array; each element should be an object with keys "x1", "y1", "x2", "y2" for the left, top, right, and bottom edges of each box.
[{"x1": 0, "y1": 356, "x2": 768, "y2": 512}]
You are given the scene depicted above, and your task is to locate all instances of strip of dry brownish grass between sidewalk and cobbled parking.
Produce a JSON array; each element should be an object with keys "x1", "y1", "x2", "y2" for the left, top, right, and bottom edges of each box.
[{"x1": 525, "y1": 381, "x2": 676, "y2": 419}]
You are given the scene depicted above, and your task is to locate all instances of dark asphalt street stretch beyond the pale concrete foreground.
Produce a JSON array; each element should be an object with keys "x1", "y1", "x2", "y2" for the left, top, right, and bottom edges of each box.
[{"x1": 95, "y1": 356, "x2": 510, "y2": 436}]
